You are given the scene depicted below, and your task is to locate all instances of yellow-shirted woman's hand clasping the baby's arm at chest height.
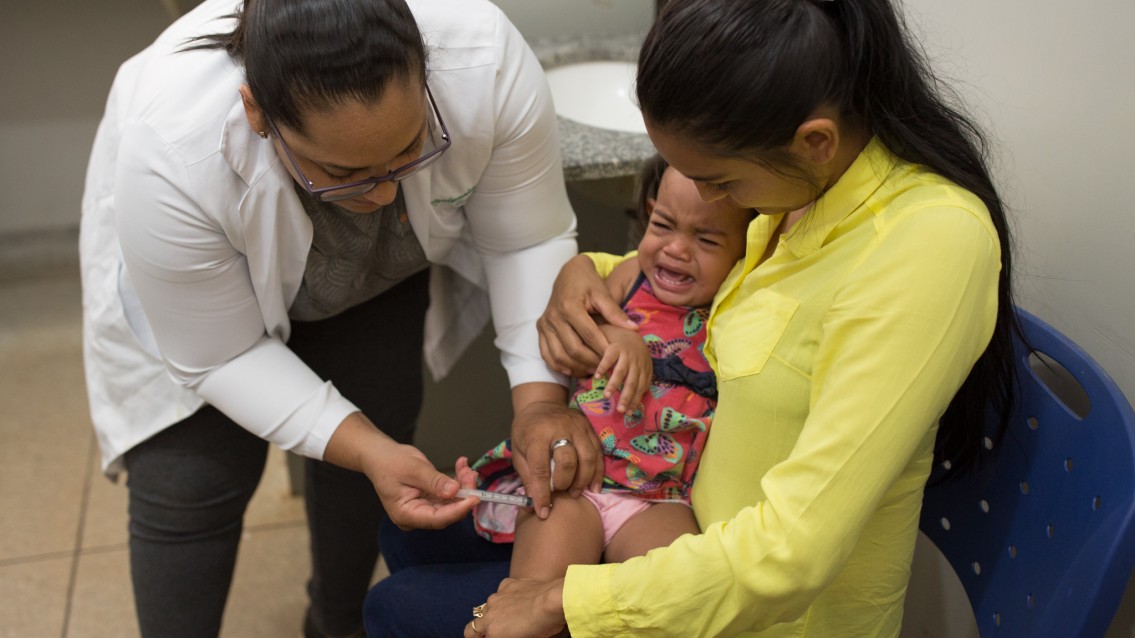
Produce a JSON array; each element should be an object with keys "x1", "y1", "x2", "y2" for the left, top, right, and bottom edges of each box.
[{"x1": 536, "y1": 254, "x2": 637, "y2": 377}]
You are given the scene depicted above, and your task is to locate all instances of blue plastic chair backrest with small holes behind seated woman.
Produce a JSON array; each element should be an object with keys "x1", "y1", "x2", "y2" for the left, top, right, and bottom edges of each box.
[{"x1": 919, "y1": 310, "x2": 1135, "y2": 638}]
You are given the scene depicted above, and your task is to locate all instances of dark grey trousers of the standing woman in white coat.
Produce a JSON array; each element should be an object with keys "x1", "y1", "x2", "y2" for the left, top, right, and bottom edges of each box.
[{"x1": 126, "y1": 271, "x2": 429, "y2": 638}]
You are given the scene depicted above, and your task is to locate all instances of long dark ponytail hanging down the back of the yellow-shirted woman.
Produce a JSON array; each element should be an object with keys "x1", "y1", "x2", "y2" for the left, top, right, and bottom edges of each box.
[{"x1": 822, "y1": 0, "x2": 1019, "y2": 475}]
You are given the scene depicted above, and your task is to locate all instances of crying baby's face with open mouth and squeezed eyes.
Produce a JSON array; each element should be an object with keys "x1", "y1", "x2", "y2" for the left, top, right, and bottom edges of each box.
[{"x1": 638, "y1": 168, "x2": 755, "y2": 307}]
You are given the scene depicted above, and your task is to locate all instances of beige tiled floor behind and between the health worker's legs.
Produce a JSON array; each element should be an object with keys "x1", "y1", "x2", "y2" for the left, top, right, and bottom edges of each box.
[{"x1": 0, "y1": 268, "x2": 385, "y2": 638}]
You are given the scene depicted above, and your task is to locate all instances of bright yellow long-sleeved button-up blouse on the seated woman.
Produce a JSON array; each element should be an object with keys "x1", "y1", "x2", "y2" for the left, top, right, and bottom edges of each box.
[{"x1": 564, "y1": 140, "x2": 1000, "y2": 638}]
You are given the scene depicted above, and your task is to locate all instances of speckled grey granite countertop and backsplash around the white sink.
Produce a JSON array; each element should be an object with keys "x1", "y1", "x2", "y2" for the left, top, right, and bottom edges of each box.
[{"x1": 530, "y1": 34, "x2": 655, "y2": 182}]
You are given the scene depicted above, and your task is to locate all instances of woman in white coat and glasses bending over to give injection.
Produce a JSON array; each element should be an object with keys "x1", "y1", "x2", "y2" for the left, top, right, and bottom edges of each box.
[{"x1": 81, "y1": 0, "x2": 586, "y2": 638}]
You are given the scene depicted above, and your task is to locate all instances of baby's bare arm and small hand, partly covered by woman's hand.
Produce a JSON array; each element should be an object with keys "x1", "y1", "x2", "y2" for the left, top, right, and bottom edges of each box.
[{"x1": 595, "y1": 259, "x2": 654, "y2": 412}]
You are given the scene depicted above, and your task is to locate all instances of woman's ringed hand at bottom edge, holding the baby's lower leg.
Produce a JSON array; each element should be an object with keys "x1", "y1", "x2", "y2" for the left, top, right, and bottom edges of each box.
[{"x1": 464, "y1": 578, "x2": 568, "y2": 638}]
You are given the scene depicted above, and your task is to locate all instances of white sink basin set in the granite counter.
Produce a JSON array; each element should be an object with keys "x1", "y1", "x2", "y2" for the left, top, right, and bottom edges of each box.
[{"x1": 546, "y1": 61, "x2": 646, "y2": 133}]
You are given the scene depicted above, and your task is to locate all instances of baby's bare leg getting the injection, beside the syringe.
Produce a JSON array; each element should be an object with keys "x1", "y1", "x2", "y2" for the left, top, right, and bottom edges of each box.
[{"x1": 508, "y1": 493, "x2": 603, "y2": 580}]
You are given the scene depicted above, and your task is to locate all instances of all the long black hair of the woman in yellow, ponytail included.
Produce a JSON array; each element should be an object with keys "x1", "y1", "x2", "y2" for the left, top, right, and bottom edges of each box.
[{"x1": 637, "y1": 0, "x2": 1019, "y2": 476}]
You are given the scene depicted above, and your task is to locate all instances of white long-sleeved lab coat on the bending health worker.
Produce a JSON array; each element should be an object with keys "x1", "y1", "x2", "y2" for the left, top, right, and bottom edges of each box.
[{"x1": 79, "y1": 0, "x2": 577, "y2": 477}]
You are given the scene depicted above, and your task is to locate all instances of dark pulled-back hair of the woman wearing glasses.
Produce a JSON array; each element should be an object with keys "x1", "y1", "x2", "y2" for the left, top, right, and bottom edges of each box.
[{"x1": 184, "y1": 0, "x2": 426, "y2": 133}]
